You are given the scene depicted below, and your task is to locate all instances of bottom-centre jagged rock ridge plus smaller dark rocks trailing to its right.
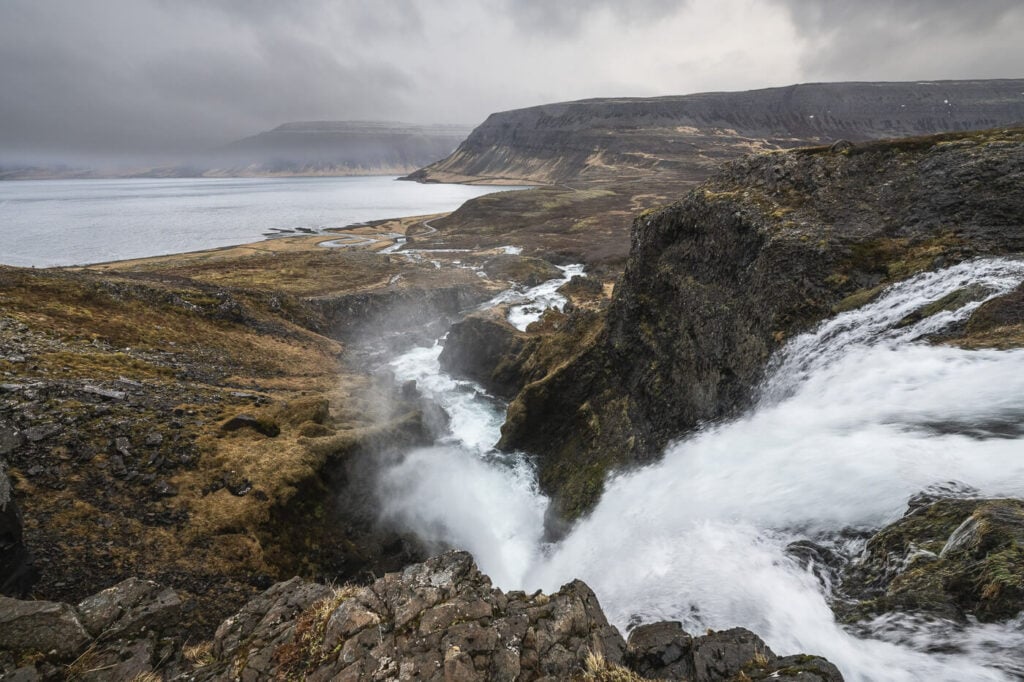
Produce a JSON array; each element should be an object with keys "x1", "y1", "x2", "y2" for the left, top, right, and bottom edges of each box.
[{"x1": 200, "y1": 552, "x2": 843, "y2": 682}]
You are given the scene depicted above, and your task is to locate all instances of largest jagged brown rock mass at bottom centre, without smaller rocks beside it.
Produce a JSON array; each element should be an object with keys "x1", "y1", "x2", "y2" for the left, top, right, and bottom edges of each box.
[{"x1": 204, "y1": 552, "x2": 626, "y2": 680}]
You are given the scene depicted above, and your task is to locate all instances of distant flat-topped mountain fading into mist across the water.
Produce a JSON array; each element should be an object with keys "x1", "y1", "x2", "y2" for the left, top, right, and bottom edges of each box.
[{"x1": 214, "y1": 121, "x2": 471, "y2": 173}]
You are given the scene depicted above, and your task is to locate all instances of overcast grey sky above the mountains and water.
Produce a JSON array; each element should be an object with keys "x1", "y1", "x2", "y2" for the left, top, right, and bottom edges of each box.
[{"x1": 0, "y1": 0, "x2": 1024, "y2": 163}]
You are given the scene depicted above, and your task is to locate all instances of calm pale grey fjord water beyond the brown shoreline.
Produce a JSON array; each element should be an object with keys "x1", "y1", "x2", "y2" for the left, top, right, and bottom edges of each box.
[{"x1": 0, "y1": 176, "x2": 510, "y2": 267}]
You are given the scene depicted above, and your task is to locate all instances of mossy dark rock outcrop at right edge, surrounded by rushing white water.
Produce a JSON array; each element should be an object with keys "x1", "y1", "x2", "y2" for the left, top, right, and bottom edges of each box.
[{"x1": 843, "y1": 499, "x2": 1024, "y2": 622}]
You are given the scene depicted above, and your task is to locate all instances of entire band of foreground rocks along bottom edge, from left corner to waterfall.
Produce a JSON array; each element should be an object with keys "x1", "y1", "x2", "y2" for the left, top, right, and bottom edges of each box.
[{"x1": 0, "y1": 552, "x2": 843, "y2": 682}]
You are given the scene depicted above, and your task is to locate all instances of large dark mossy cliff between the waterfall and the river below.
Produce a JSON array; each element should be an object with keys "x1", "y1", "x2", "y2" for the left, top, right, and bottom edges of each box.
[{"x1": 501, "y1": 129, "x2": 1024, "y2": 515}]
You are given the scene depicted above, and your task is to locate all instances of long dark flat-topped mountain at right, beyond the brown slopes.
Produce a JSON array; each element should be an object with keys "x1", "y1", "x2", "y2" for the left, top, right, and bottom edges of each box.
[{"x1": 410, "y1": 79, "x2": 1024, "y2": 183}]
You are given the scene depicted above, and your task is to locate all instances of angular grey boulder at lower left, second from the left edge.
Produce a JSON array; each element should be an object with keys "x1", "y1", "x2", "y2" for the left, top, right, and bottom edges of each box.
[{"x1": 78, "y1": 578, "x2": 181, "y2": 640}]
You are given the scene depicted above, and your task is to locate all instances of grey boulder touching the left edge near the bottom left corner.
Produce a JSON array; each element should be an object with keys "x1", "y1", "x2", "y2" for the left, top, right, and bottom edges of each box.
[{"x1": 0, "y1": 597, "x2": 91, "y2": 658}]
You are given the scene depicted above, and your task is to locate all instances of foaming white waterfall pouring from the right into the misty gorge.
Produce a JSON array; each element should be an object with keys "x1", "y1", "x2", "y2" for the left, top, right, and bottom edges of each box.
[{"x1": 382, "y1": 260, "x2": 1024, "y2": 680}]
